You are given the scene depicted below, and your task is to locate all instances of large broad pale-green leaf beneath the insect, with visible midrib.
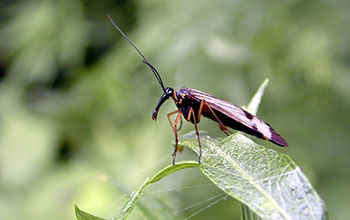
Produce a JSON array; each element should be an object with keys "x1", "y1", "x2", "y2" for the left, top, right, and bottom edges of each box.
[{"x1": 182, "y1": 133, "x2": 327, "y2": 220}]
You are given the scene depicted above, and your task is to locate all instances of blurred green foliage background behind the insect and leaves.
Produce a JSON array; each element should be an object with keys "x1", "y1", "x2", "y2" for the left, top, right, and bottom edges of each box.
[{"x1": 0, "y1": 0, "x2": 350, "y2": 220}]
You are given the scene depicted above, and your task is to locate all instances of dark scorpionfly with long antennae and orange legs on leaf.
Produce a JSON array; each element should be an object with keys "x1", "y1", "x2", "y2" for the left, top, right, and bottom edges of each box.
[{"x1": 107, "y1": 15, "x2": 288, "y2": 164}]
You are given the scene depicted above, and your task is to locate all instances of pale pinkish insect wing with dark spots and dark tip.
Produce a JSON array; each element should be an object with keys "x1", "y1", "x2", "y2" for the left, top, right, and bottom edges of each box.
[{"x1": 188, "y1": 89, "x2": 288, "y2": 146}]
